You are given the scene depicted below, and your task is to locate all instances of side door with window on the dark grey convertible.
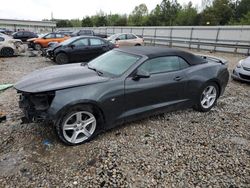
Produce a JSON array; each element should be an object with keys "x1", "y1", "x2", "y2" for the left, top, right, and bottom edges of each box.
[{"x1": 124, "y1": 56, "x2": 189, "y2": 117}]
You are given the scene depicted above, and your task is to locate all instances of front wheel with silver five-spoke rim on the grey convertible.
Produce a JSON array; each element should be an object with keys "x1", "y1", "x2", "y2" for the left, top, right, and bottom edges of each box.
[{"x1": 55, "y1": 105, "x2": 102, "y2": 146}]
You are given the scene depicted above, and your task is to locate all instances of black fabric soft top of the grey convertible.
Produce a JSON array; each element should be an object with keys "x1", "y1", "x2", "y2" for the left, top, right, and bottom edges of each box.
[{"x1": 116, "y1": 46, "x2": 207, "y2": 65}]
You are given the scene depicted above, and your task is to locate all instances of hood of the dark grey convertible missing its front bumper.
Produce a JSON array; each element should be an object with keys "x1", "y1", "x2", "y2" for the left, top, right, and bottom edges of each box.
[{"x1": 14, "y1": 63, "x2": 109, "y2": 93}]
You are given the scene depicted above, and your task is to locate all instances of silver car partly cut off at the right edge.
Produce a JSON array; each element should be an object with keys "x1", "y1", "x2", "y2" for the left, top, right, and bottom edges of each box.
[{"x1": 232, "y1": 56, "x2": 250, "y2": 82}]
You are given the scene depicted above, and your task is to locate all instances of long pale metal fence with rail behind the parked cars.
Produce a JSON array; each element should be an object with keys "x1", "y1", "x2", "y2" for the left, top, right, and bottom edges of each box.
[{"x1": 59, "y1": 26, "x2": 250, "y2": 55}]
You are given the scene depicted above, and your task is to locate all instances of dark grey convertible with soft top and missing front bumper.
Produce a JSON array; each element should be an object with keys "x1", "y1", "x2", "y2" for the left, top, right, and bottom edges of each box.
[{"x1": 15, "y1": 47, "x2": 229, "y2": 145}]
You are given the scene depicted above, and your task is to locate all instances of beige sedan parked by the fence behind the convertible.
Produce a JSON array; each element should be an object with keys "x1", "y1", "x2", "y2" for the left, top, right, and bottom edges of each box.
[{"x1": 107, "y1": 33, "x2": 144, "y2": 46}]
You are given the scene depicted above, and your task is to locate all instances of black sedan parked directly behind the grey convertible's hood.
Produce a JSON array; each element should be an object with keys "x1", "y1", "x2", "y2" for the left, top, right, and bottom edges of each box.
[{"x1": 47, "y1": 36, "x2": 115, "y2": 64}]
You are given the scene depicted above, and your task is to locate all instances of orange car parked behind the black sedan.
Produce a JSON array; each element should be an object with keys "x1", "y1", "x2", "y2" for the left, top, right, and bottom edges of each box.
[{"x1": 27, "y1": 33, "x2": 70, "y2": 50}]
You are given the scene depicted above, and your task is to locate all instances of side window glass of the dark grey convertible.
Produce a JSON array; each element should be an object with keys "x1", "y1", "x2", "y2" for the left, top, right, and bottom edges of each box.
[{"x1": 139, "y1": 56, "x2": 189, "y2": 74}]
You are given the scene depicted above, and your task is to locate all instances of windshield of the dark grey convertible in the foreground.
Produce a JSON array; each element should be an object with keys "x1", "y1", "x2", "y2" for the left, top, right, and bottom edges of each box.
[{"x1": 88, "y1": 50, "x2": 141, "y2": 76}]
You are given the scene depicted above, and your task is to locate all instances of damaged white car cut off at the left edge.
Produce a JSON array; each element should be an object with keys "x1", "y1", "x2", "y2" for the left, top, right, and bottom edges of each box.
[{"x1": 0, "y1": 34, "x2": 25, "y2": 57}]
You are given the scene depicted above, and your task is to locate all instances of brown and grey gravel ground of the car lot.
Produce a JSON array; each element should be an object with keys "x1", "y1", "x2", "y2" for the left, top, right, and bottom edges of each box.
[{"x1": 0, "y1": 49, "x2": 250, "y2": 188}]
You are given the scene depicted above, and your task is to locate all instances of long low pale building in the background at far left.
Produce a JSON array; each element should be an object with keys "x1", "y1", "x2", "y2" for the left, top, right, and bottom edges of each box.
[{"x1": 0, "y1": 19, "x2": 56, "y2": 33}]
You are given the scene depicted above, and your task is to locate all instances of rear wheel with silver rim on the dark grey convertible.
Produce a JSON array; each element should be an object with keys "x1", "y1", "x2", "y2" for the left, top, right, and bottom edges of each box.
[{"x1": 194, "y1": 82, "x2": 219, "y2": 112}]
